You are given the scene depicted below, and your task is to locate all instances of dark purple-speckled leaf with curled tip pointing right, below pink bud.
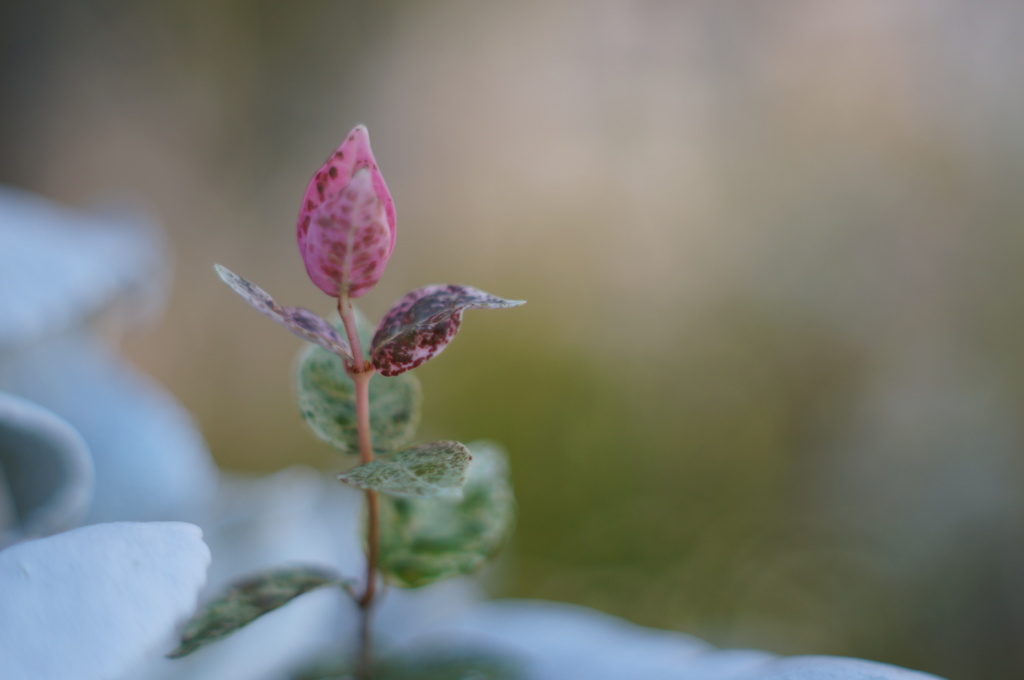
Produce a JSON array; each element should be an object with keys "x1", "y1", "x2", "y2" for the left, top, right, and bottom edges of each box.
[{"x1": 370, "y1": 284, "x2": 525, "y2": 376}]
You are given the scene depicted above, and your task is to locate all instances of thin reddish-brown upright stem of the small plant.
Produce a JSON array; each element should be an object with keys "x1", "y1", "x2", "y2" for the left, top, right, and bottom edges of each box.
[{"x1": 338, "y1": 293, "x2": 380, "y2": 680}]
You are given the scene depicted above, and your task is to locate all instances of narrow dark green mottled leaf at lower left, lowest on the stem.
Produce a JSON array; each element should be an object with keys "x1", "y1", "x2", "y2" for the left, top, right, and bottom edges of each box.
[{"x1": 168, "y1": 566, "x2": 346, "y2": 658}]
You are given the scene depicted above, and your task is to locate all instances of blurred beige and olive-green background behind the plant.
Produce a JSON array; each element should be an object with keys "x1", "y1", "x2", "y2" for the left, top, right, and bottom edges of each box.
[{"x1": 0, "y1": 0, "x2": 1024, "y2": 680}]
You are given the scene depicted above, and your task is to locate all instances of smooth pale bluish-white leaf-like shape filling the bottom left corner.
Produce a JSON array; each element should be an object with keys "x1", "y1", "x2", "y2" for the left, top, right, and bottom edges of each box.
[{"x1": 0, "y1": 522, "x2": 210, "y2": 680}]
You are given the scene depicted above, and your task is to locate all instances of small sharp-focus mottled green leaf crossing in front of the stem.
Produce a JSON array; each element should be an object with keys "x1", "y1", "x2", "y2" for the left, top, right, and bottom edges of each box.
[{"x1": 338, "y1": 441, "x2": 472, "y2": 498}]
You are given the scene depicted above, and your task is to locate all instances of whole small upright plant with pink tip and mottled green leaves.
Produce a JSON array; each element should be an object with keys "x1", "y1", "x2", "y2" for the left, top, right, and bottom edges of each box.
[{"x1": 170, "y1": 125, "x2": 523, "y2": 679}]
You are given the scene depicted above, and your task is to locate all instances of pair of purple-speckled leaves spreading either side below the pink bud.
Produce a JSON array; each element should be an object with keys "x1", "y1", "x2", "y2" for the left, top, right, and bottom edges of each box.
[{"x1": 215, "y1": 264, "x2": 525, "y2": 377}]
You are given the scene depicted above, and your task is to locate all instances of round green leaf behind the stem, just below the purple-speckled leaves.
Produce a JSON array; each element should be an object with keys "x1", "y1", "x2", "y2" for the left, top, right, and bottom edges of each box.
[{"x1": 297, "y1": 346, "x2": 423, "y2": 454}]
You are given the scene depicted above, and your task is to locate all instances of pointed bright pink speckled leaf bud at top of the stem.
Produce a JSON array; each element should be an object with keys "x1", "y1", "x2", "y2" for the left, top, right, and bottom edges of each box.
[{"x1": 296, "y1": 125, "x2": 395, "y2": 298}]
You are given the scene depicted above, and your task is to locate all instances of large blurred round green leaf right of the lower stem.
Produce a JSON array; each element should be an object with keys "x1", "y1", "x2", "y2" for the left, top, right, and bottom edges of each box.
[{"x1": 379, "y1": 442, "x2": 515, "y2": 588}]
